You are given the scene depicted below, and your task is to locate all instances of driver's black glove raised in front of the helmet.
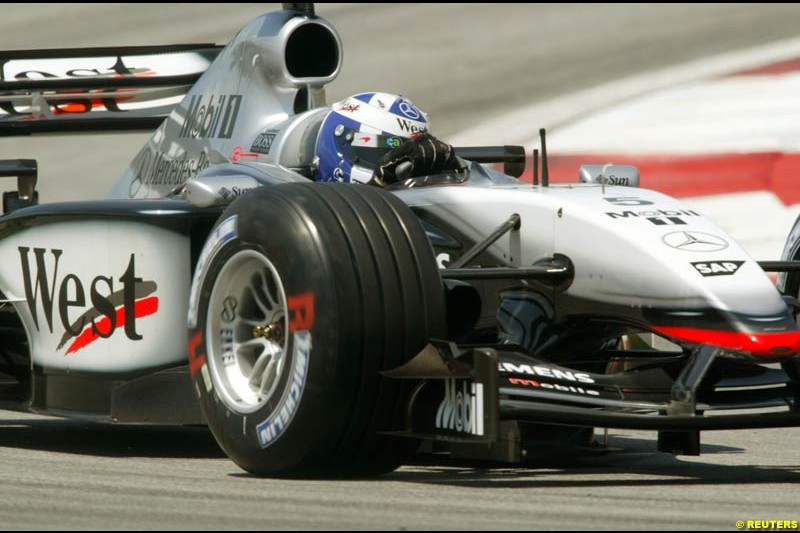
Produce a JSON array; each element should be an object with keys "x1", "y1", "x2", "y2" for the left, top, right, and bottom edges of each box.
[{"x1": 372, "y1": 133, "x2": 462, "y2": 186}]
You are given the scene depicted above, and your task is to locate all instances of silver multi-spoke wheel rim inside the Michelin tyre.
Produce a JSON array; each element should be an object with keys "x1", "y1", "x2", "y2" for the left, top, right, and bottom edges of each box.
[{"x1": 206, "y1": 250, "x2": 288, "y2": 413}]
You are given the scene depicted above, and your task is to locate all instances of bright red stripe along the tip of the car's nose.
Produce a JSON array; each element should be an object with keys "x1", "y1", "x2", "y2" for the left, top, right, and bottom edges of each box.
[{"x1": 653, "y1": 326, "x2": 800, "y2": 357}]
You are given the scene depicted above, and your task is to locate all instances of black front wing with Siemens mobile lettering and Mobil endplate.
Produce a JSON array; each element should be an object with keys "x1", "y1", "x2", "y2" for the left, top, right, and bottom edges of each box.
[{"x1": 385, "y1": 341, "x2": 800, "y2": 456}]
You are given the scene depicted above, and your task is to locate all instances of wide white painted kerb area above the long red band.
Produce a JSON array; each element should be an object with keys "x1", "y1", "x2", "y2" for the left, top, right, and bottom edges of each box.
[{"x1": 548, "y1": 71, "x2": 800, "y2": 156}]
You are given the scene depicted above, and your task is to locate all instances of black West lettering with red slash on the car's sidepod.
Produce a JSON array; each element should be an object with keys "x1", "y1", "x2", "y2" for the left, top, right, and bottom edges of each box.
[{"x1": 18, "y1": 246, "x2": 158, "y2": 354}]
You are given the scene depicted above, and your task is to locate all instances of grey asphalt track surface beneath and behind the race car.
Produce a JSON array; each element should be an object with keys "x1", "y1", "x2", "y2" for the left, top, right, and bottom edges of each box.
[{"x1": 0, "y1": 4, "x2": 800, "y2": 530}]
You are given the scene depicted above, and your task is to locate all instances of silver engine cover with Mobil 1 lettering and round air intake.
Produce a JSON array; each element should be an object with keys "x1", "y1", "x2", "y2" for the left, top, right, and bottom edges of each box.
[{"x1": 108, "y1": 11, "x2": 342, "y2": 198}]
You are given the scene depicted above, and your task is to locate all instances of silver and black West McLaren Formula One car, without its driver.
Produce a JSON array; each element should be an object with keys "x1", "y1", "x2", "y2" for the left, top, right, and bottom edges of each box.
[{"x1": 0, "y1": 4, "x2": 800, "y2": 475}]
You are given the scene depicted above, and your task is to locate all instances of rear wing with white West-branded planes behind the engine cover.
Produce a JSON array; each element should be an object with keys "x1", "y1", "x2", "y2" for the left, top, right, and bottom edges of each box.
[{"x1": 0, "y1": 44, "x2": 223, "y2": 136}]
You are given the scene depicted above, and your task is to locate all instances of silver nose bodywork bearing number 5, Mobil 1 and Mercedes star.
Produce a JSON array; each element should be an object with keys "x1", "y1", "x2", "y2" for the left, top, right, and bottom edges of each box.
[{"x1": 398, "y1": 185, "x2": 785, "y2": 316}]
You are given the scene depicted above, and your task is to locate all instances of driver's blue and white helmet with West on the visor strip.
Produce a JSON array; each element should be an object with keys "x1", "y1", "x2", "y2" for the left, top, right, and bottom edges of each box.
[{"x1": 315, "y1": 93, "x2": 428, "y2": 183}]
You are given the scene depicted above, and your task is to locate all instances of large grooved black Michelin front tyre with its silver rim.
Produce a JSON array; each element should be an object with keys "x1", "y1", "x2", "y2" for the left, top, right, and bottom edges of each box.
[{"x1": 189, "y1": 183, "x2": 445, "y2": 475}]
